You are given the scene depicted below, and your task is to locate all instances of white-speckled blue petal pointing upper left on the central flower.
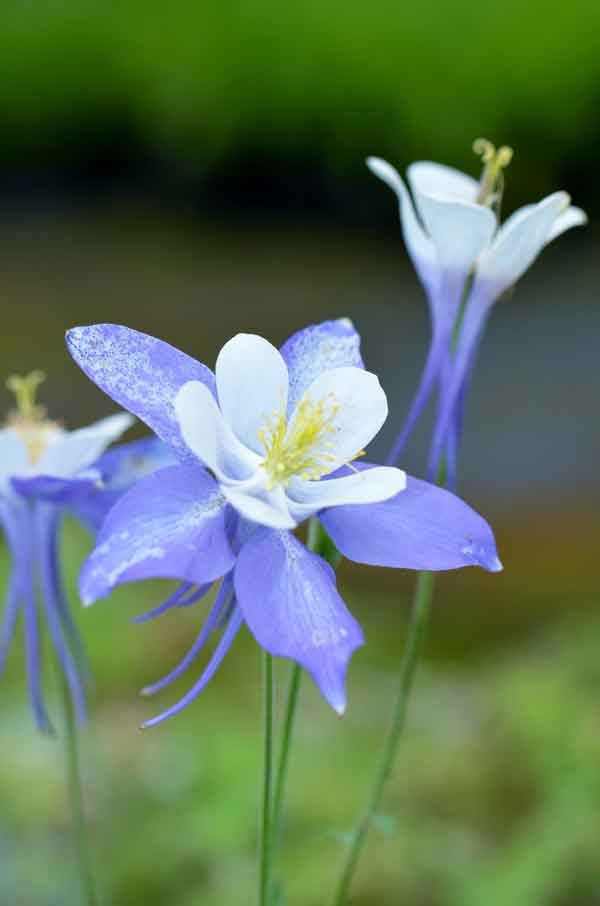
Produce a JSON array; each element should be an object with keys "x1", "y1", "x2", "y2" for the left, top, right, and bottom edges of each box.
[{"x1": 67, "y1": 324, "x2": 215, "y2": 459}]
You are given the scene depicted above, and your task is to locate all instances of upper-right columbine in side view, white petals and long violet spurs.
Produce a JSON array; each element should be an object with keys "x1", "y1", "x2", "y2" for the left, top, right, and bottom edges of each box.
[{"x1": 367, "y1": 139, "x2": 586, "y2": 483}]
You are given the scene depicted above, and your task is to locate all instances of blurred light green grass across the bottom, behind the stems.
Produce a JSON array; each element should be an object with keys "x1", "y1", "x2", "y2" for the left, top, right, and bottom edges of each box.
[{"x1": 0, "y1": 512, "x2": 600, "y2": 906}]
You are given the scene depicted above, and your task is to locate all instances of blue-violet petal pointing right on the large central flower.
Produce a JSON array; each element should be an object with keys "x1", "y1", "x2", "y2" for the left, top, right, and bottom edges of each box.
[{"x1": 319, "y1": 465, "x2": 502, "y2": 572}]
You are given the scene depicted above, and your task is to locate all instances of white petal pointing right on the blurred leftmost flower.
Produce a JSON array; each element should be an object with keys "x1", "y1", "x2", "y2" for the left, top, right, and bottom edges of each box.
[{"x1": 35, "y1": 412, "x2": 135, "y2": 478}]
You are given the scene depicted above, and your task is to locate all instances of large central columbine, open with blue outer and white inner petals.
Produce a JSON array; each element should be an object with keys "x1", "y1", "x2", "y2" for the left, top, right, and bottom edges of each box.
[{"x1": 67, "y1": 320, "x2": 500, "y2": 726}]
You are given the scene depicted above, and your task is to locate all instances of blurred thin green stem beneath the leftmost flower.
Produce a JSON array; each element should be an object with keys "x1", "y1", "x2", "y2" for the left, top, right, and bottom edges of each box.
[{"x1": 59, "y1": 674, "x2": 100, "y2": 906}]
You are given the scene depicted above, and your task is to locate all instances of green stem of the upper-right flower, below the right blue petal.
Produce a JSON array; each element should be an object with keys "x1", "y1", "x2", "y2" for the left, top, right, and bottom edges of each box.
[{"x1": 333, "y1": 572, "x2": 435, "y2": 906}]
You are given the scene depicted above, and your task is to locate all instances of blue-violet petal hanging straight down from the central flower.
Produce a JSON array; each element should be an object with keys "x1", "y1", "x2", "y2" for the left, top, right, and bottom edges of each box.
[{"x1": 235, "y1": 528, "x2": 364, "y2": 714}]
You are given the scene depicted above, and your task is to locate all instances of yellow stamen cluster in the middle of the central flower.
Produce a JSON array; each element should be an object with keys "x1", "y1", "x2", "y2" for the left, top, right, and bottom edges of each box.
[{"x1": 258, "y1": 393, "x2": 342, "y2": 490}]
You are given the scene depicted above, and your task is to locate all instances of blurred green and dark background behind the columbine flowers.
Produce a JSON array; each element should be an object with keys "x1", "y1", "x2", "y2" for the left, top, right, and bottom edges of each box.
[{"x1": 0, "y1": 0, "x2": 600, "y2": 906}]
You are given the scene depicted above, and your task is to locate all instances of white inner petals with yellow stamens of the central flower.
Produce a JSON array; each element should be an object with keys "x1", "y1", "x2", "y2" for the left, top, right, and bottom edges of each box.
[{"x1": 174, "y1": 334, "x2": 406, "y2": 529}]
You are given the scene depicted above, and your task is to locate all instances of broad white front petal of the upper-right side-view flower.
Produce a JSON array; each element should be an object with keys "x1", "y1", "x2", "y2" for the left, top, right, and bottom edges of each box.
[{"x1": 416, "y1": 194, "x2": 497, "y2": 278}]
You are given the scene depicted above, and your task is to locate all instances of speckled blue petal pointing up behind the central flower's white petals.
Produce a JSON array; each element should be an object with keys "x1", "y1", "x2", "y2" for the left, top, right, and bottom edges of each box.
[{"x1": 280, "y1": 318, "x2": 364, "y2": 413}]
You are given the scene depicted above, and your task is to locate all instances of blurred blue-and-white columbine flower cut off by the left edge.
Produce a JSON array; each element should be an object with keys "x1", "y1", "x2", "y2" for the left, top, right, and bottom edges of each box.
[{"x1": 0, "y1": 372, "x2": 154, "y2": 730}]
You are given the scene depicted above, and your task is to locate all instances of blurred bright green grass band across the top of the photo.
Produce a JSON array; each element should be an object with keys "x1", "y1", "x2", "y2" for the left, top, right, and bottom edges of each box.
[{"x1": 0, "y1": 0, "x2": 600, "y2": 205}]
